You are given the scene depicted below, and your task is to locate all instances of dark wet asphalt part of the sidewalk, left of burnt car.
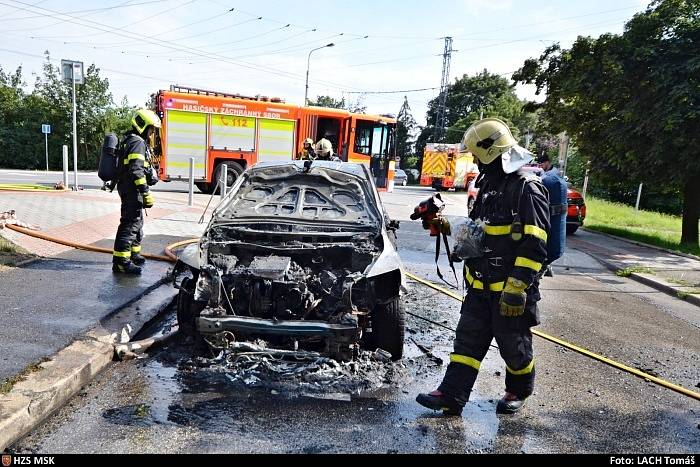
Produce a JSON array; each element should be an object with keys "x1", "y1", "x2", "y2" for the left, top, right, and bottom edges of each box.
[{"x1": 0, "y1": 235, "x2": 175, "y2": 381}]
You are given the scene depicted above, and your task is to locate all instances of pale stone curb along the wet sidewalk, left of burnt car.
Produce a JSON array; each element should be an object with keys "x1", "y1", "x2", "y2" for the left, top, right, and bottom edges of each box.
[{"x1": 0, "y1": 281, "x2": 175, "y2": 452}]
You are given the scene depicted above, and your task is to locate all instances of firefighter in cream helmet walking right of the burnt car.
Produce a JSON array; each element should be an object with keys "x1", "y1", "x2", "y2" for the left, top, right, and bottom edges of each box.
[{"x1": 416, "y1": 118, "x2": 549, "y2": 415}]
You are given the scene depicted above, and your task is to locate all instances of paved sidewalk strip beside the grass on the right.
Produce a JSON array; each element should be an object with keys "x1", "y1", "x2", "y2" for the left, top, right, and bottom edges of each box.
[{"x1": 566, "y1": 229, "x2": 700, "y2": 306}]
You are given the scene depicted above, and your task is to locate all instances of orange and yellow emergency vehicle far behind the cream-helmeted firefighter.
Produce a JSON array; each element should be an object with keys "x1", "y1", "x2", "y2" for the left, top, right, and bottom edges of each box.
[{"x1": 420, "y1": 143, "x2": 478, "y2": 191}]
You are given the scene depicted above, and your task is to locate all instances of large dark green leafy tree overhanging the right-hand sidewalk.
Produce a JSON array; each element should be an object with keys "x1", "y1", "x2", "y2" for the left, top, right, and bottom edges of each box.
[{"x1": 513, "y1": 0, "x2": 700, "y2": 249}]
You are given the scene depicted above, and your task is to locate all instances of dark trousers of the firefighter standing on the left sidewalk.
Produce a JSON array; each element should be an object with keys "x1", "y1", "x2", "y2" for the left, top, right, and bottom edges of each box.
[{"x1": 112, "y1": 182, "x2": 143, "y2": 263}]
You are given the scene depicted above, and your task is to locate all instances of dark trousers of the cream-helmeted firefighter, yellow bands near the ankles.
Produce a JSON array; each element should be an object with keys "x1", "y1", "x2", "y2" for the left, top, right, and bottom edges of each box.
[{"x1": 438, "y1": 291, "x2": 537, "y2": 405}]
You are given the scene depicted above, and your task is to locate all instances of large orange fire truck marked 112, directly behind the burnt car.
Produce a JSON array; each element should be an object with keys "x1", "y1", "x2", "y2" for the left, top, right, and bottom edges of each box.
[{"x1": 156, "y1": 86, "x2": 396, "y2": 193}]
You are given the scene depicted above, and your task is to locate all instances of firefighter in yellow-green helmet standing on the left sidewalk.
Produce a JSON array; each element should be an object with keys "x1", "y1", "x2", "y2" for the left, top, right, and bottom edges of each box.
[{"x1": 112, "y1": 109, "x2": 160, "y2": 274}]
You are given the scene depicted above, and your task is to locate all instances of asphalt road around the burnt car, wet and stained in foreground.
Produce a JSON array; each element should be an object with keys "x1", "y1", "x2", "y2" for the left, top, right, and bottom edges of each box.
[{"x1": 13, "y1": 222, "x2": 700, "y2": 453}]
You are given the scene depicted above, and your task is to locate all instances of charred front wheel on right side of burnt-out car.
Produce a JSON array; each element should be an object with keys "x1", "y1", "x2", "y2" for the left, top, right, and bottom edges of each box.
[{"x1": 368, "y1": 298, "x2": 406, "y2": 361}]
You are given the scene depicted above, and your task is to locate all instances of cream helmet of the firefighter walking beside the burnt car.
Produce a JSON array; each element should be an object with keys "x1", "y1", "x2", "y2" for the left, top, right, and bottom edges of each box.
[{"x1": 462, "y1": 118, "x2": 516, "y2": 164}]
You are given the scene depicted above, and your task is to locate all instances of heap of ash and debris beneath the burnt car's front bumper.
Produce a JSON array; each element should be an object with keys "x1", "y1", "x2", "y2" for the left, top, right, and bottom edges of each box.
[{"x1": 182, "y1": 341, "x2": 409, "y2": 395}]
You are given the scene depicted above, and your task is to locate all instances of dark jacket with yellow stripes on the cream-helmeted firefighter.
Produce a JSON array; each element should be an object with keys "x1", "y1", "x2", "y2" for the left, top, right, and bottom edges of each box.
[{"x1": 464, "y1": 169, "x2": 549, "y2": 300}]
